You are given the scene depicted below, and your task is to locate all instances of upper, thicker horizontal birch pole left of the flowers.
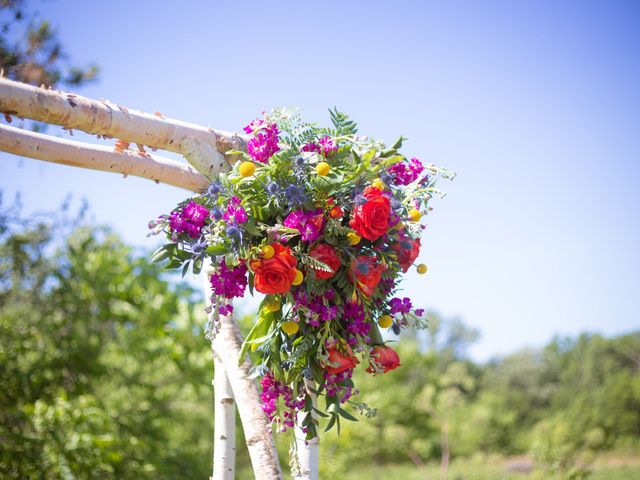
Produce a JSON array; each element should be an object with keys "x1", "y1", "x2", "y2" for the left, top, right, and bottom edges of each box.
[{"x1": 0, "y1": 78, "x2": 247, "y2": 176}]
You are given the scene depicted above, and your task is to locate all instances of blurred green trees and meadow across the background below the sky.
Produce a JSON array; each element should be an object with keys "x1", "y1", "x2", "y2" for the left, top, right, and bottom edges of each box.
[{"x1": 0, "y1": 204, "x2": 640, "y2": 480}]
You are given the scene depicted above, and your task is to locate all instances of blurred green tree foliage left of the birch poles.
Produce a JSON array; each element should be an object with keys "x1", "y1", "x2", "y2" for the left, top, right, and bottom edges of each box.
[{"x1": 0, "y1": 201, "x2": 213, "y2": 479}]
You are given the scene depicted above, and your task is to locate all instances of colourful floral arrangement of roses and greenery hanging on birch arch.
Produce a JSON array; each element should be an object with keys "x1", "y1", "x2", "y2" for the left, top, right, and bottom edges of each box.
[{"x1": 150, "y1": 109, "x2": 453, "y2": 438}]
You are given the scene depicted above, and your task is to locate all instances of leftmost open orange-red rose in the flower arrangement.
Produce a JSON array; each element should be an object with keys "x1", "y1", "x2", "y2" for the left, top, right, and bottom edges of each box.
[{"x1": 251, "y1": 243, "x2": 297, "y2": 294}]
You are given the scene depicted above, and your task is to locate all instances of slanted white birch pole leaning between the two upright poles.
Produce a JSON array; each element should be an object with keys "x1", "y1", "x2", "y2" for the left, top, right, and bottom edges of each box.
[{"x1": 203, "y1": 263, "x2": 282, "y2": 480}]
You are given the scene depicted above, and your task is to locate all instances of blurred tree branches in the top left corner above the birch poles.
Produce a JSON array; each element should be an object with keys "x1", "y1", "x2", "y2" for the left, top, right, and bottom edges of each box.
[{"x1": 0, "y1": 0, "x2": 98, "y2": 87}]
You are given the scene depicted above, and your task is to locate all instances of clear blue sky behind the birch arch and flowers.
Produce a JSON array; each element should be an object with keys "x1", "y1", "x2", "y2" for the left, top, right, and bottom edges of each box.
[{"x1": 0, "y1": 0, "x2": 640, "y2": 359}]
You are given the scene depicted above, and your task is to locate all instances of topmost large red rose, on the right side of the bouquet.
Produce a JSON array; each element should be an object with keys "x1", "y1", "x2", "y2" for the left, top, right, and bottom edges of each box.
[{"x1": 349, "y1": 187, "x2": 391, "y2": 241}]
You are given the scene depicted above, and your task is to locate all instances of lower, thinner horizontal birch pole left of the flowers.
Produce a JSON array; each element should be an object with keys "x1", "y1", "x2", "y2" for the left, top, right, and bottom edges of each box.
[{"x1": 0, "y1": 124, "x2": 209, "y2": 191}]
